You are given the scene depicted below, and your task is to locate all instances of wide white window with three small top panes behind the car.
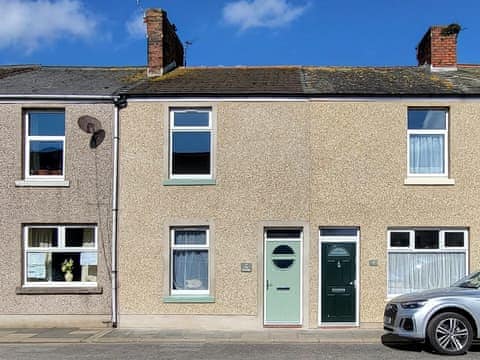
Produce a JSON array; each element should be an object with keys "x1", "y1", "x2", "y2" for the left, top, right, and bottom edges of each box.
[{"x1": 387, "y1": 228, "x2": 468, "y2": 296}]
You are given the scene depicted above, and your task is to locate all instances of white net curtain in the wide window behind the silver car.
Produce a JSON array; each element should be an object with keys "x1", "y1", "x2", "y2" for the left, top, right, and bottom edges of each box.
[{"x1": 388, "y1": 252, "x2": 465, "y2": 295}]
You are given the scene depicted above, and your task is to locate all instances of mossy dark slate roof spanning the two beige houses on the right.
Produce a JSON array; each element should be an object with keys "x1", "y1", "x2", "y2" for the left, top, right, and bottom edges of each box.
[{"x1": 128, "y1": 66, "x2": 480, "y2": 97}]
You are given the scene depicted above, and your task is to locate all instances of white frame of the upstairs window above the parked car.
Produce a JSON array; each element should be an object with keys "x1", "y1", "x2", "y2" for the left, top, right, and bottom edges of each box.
[{"x1": 407, "y1": 107, "x2": 449, "y2": 178}]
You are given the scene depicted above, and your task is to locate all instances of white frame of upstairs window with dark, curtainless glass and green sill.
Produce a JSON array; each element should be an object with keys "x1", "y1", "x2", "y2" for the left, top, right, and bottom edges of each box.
[{"x1": 168, "y1": 108, "x2": 213, "y2": 179}]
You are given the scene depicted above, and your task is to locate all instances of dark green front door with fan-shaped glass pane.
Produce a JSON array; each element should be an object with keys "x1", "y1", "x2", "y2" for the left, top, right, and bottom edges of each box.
[{"x1": 321, "y1": 243, "x2": 356, "y2": 323}]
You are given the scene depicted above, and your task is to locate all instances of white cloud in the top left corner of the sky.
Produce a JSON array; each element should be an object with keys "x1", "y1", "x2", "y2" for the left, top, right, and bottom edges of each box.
[{"x1": 0, "y1": 0, "x2": 98, "y2": 53}]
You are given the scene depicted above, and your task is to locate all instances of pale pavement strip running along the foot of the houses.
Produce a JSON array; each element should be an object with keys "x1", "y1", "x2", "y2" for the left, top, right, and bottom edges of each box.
[{"x1": 0, "y1": 328, "x2": 384, "y2": 344}]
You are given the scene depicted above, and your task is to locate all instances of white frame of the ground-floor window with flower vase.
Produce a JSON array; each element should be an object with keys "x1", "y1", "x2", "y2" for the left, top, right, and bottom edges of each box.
[{"x1": 23, "y1": 225, "x2": 98, "y2": 287}]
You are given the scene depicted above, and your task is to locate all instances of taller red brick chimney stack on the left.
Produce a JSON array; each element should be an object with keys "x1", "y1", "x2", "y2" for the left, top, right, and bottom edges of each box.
[{"x1": 144, "y1": 9, "x2": 183, "y2": 76}]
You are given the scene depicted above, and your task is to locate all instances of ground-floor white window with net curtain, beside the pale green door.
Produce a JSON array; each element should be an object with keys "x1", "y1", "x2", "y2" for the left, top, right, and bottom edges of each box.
[{"x1": 170, "y1": 227, "x2": 210, "y2": 295}]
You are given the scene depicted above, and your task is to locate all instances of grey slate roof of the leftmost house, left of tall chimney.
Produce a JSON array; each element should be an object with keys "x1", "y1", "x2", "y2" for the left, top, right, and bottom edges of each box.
[{"x1": 0, "y1": 66, "x2": 146, "y2": 97}]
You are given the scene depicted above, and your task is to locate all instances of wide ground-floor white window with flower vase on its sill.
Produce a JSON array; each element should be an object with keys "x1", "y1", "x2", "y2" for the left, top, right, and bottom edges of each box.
[{"x1": 23, "y1": 225, "x2": 98, "y2": 287}]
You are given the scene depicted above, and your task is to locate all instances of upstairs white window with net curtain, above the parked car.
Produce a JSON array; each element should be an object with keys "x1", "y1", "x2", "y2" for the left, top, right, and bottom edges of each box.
[{"x1": 407, "y1": 108, "x2": 448, "y2": 177}]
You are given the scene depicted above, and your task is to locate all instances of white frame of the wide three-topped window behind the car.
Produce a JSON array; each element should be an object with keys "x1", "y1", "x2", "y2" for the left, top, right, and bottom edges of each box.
[{"x1": 387, "y1": 227, "x2": 469, "y2": 298}]
